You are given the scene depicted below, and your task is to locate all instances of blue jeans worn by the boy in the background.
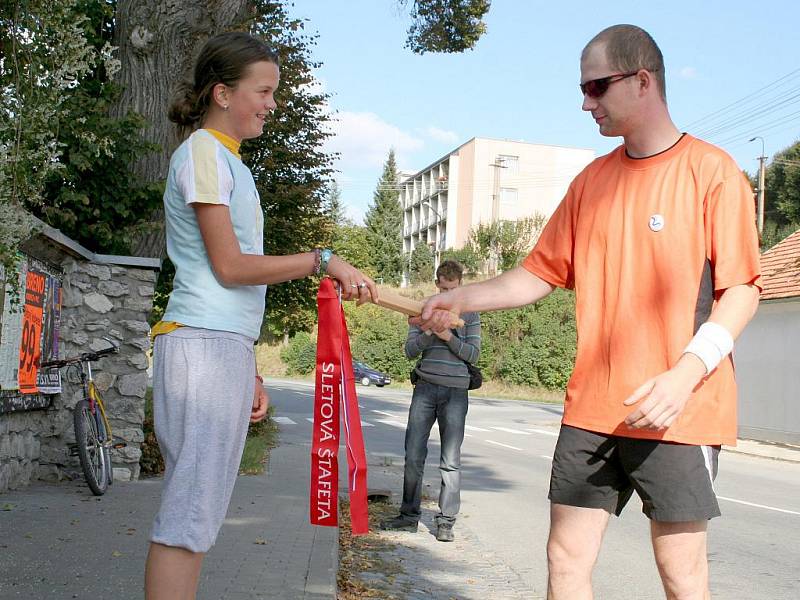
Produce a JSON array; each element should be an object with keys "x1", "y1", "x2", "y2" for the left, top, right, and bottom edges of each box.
[{"x1": 400, "y1": 380, "x2": 469, "y2": 523}]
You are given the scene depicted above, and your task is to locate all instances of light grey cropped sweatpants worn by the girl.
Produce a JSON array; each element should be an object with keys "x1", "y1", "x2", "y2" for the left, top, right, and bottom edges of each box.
[{"x1": 150, "y1": 327, "x2": 255, "y2": 552}]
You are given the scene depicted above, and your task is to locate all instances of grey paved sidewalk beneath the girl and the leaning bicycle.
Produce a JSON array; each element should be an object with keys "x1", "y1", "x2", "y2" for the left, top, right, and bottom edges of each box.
[{"x1": 0, "y1": 436, "x2": 338, "y2": 600}]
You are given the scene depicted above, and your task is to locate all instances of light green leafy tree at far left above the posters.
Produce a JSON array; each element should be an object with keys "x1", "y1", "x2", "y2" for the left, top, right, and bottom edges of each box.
[{"x1": 0, "y1": 0, "x2": 106, "y2": 282}]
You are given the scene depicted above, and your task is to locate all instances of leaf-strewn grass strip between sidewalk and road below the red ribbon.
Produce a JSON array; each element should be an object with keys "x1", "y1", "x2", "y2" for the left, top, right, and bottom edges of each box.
[{"x1": 336, "y1": 500, "x2": 403, "y2": 600}]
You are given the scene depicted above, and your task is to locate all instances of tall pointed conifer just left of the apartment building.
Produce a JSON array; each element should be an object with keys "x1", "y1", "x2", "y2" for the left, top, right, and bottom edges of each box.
[{"x1": 364, "y1": 149, "x2": 403, "y2": 285}]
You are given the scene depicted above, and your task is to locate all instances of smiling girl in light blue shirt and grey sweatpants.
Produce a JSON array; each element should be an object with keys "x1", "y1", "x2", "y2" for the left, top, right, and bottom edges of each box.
[{"x1": 145, "y1": 32, "x2": 377, "y2": 600}]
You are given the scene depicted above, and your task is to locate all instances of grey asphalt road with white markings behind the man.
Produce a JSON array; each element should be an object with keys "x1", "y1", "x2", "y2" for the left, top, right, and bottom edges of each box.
[{"x1": 268, "y1": 381, "x2": 800, "y2": 600}]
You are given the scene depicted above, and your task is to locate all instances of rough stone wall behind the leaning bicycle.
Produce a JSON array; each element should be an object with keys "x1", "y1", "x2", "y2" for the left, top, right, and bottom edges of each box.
[{"x1": 0, "y1": 225, "x2": 159, "y2": 492}]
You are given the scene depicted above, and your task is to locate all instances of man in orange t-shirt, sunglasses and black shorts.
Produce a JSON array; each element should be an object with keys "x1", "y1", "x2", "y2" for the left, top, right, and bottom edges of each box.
[{"x1": 415, "y1": 25, "x2": 760, "y2": 600}]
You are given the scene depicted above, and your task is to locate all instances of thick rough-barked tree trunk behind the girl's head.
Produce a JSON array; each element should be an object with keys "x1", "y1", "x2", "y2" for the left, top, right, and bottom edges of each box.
[{"x1": 112, "y1": 0, "x2": 253, "y2": 258}]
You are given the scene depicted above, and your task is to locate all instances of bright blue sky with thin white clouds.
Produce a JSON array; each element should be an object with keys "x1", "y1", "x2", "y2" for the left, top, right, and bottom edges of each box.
[{"x1": 290, "y1": 0, "x2": 800, "y2": 221}]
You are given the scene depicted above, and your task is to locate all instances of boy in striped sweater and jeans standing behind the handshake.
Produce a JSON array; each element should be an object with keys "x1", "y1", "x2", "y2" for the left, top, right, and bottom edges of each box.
[{"x1": 382, "y1": 260, "x2": 481, "y2": 542}]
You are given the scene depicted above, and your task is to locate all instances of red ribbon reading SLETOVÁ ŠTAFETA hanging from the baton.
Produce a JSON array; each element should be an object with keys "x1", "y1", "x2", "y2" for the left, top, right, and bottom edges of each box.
[{"x1": 311, "y1": 278, "x2": 369, "y2": 535}]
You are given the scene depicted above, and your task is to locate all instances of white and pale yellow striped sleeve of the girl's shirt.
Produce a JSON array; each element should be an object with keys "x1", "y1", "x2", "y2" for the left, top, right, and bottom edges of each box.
[{"x1": 176, "y1": 133, "x2": 233, "y2": 206}]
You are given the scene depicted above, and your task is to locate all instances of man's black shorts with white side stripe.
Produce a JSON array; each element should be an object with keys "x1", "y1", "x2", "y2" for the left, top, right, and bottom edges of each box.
[{"x1": 549, "y1": 425, "x2": 720, "y2": 522}]
